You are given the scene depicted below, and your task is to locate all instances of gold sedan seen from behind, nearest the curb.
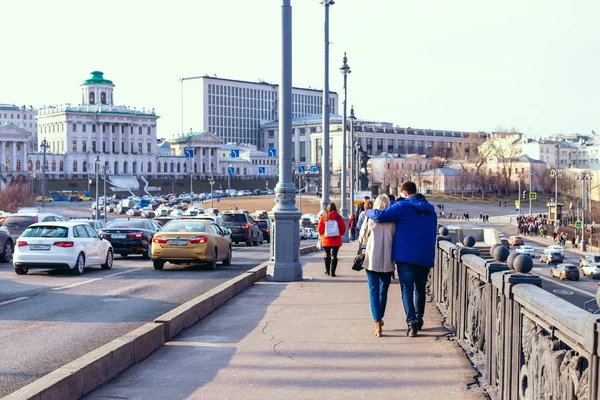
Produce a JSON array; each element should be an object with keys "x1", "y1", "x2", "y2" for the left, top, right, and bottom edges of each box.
[{"x1": 152, "y1": 219, "x2": 231, "y2": 270}]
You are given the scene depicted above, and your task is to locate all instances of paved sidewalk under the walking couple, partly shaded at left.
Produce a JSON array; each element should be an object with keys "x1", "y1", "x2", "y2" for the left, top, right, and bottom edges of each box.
[{"x1": 85, "y1": 244, "x2": 484, "y2": 400}]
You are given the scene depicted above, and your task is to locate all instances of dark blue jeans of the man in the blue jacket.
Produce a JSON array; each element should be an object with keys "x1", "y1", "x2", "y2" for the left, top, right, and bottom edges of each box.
[{"x1": 396, "y1": 262, "x2": 429, "y2": 324}]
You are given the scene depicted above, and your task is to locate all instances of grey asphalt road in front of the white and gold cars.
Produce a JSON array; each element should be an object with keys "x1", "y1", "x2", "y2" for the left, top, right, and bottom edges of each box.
[{"x1": 0, "y1": 238, "x2": 269, "y2": 397}]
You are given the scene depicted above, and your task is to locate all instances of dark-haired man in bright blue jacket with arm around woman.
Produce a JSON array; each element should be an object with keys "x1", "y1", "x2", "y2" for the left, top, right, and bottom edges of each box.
[{"x1": 366, "y1": 181, "x2": 437, "y2": 336}]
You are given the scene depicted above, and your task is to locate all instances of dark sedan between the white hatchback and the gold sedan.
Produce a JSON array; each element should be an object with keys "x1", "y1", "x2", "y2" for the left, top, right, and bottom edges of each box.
[{"x1": 100, "y1": 218, "x2": 160, "y2": 259}]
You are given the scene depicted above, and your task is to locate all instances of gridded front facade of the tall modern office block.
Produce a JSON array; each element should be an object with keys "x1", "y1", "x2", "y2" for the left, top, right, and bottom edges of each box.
[{"x1": 201, "y1": 75, "x2": 338, "y2": 148}]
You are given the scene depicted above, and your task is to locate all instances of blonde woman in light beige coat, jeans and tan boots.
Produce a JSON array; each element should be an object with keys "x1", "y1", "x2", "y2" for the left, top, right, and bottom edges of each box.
[{"x1": 361, "y1": 194, "x2": 396, "y2": 337}]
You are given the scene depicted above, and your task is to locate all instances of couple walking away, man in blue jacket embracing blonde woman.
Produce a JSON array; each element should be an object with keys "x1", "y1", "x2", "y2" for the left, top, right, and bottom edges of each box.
[{"x1": 360, "y1": 182, "x2": 437, "y2": 336}]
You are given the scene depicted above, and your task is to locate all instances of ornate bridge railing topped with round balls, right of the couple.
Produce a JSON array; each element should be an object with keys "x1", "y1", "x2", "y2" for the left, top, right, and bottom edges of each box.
[{"x1": 430, "y1": 229, "x2": 600, "y2": 400}]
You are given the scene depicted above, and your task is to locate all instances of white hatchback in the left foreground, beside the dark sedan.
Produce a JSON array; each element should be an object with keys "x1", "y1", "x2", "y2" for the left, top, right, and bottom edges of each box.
[{"x1": 13, "y1": 221, "x2": 113, "y2": 275}]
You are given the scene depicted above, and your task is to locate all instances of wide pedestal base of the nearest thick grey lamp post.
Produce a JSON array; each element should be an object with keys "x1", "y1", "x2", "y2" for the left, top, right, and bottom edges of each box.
[{"x1": 267, "y1": 208, "x2": 302, "y2": 282}]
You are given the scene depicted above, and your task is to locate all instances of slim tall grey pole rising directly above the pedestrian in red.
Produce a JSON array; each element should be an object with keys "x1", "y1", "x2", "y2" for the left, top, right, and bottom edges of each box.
[{"x1": 320, "y1": 0, "x2": 335, "y2": 211}]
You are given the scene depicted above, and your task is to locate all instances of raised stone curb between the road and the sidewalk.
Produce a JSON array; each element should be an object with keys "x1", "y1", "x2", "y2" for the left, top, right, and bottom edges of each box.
[{"x1": 3, "y1": 245, "x2": 316, "y2": 400}]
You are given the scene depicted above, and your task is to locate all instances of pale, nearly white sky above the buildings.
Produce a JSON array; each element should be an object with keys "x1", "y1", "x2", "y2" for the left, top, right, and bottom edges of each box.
[{"x1": 0, "y1": 0, "x2": 600, "y2": 137}]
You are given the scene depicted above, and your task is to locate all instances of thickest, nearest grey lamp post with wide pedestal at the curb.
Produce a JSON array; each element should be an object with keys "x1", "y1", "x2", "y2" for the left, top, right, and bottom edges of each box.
[{"x1": 267, "y1": 0, "x2": 302, "y2": 282}]
